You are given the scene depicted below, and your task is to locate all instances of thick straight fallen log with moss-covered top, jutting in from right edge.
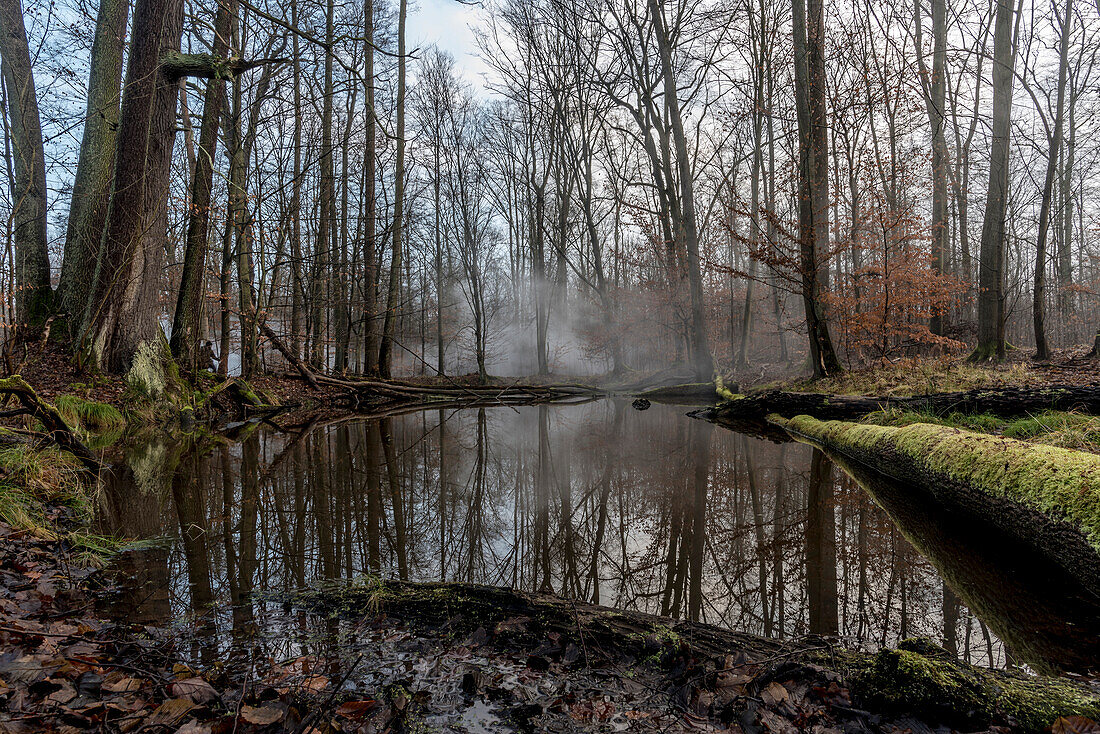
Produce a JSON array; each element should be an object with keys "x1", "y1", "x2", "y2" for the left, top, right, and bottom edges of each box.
[{"x1": 771, "y1": 416, "x2": 1100, "y2": 593}]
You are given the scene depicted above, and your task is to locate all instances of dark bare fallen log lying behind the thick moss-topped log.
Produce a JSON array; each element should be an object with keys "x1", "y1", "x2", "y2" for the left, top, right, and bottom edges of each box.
[{"x1": 693, "y1": 385, "x2": 1100, "y2": 423}]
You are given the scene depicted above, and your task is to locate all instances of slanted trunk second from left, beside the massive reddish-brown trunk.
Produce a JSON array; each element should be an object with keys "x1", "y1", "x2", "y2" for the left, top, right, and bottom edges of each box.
[{"x1": 57, "y1": 0, "x2": 130, "y2": 330}]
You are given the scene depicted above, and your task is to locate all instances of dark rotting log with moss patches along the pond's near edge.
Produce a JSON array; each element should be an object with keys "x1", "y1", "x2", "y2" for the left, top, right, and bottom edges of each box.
[{"x1": 284, "y1": 578, "x2": 1100, "y2": 732}]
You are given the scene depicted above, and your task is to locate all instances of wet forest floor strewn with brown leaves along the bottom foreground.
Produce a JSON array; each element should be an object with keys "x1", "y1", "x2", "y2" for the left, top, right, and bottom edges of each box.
[{"x1": 0, "y1": 506, "x2": 1100, "y2": 734}]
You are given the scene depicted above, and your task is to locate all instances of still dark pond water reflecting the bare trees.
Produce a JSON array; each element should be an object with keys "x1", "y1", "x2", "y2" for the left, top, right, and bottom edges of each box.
[{"x1": 99, "y1": 401, "x2": 1100, "y2": 669}]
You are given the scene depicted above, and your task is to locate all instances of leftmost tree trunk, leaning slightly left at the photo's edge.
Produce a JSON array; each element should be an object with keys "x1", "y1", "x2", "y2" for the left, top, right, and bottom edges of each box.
[{"x1": 0, "y1": 0, "x2": 53, "y2": 339}]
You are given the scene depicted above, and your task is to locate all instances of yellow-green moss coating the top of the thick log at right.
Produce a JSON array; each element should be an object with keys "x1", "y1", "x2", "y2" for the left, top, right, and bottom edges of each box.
[{"x1": 774, "y1": 416, "x2": 1100, "y2": 550}]
